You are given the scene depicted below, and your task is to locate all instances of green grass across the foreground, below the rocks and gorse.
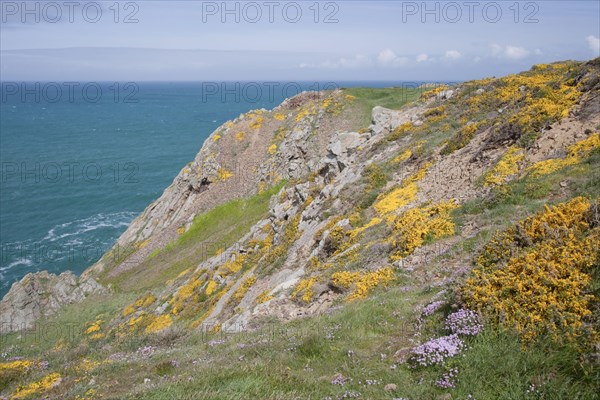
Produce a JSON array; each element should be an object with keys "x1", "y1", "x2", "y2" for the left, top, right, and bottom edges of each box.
[{"x1": 2, "y1": 267, "x2": 600, "y2": 400}]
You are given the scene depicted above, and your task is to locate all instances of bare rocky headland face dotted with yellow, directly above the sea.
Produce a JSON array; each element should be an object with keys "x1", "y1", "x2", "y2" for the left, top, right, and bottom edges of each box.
[{"x1": 85, "y1": 91, "x2": 355, "y2": 277}]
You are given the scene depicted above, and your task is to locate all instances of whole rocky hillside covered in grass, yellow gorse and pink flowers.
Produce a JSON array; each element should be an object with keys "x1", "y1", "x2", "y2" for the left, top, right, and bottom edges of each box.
[{"x1": 0, "y1": 59, "x2": 600, "y2": 400}]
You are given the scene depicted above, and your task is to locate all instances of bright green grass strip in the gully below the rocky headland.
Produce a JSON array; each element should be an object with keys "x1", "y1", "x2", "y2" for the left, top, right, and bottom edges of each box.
[{"x1": 104, "y1": 182, "x2": 285, "y2": 291}]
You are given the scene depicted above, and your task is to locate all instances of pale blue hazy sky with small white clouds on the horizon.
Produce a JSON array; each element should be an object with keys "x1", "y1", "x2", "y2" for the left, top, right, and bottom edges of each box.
[{"x1": 0, "y1": 0, "x2": 600, "y2": 81}]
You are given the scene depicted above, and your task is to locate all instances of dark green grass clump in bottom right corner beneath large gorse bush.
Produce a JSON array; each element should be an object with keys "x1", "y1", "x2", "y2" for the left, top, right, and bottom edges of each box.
[{"x1": 453, "y1": 329, "x2": 600, "y2": 400}]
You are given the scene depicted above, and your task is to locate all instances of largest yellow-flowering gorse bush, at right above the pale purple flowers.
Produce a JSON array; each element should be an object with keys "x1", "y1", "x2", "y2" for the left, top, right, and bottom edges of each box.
[{"x1": 462, "y1": 197, "x2": 600, "y2": 343}]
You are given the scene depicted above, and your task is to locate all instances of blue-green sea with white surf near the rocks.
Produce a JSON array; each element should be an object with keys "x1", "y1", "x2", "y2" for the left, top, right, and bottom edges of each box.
[{"x1": 0, "y1": 82, "x2": 426, "y2": 298}]
